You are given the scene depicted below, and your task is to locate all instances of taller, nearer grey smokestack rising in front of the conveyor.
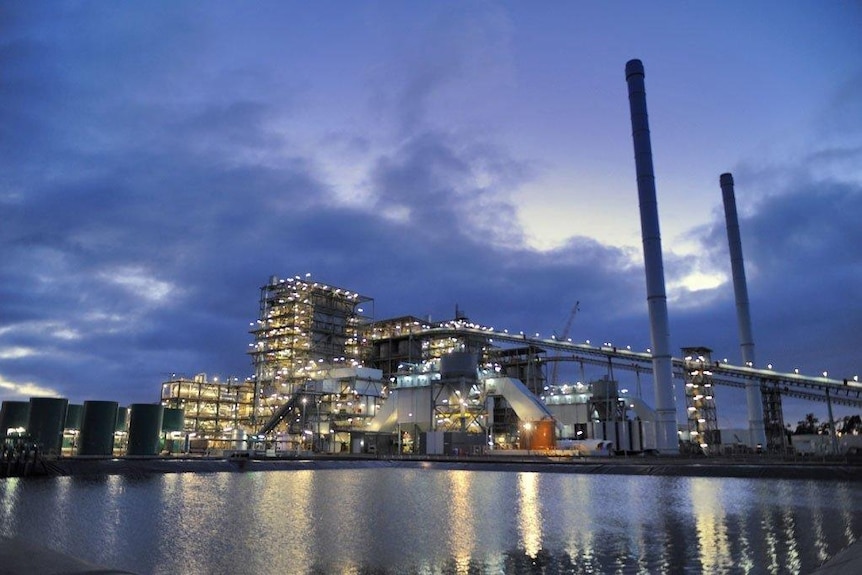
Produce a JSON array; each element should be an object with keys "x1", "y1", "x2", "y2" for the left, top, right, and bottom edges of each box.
[{"x1": 626, "y1": 60, "x2": 679, "y2": 454}]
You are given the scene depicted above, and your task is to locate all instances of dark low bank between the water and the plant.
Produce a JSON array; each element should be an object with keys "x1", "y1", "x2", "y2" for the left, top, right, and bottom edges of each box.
[{"x1": 6, "y1": 454, "x2": 862, "y2": 481}]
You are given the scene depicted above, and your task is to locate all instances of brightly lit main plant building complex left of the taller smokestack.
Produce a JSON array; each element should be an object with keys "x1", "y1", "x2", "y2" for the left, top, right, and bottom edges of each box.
[{"x1": 154, "y1": 275, "x2": 668, "y2": 460}]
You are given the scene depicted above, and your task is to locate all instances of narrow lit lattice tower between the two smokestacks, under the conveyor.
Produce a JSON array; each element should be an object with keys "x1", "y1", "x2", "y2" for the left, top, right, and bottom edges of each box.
[{"x1": 682, "y1": 347, "x2": 721, "y2": 453}]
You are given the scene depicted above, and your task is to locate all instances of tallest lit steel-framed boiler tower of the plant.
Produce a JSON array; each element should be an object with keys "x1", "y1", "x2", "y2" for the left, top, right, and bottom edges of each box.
[{"x1": 249, "y1": 276, "x2": 373, "y2": 434}]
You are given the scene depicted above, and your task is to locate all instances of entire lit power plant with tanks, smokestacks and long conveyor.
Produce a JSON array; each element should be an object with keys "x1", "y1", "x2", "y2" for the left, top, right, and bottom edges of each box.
[{"x1": 0, "y1": 60, "x2": 862, "y2": 472}]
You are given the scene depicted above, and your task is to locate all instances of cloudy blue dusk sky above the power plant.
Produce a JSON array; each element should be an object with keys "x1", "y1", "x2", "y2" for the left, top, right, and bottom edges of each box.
[{"x1": 0, "y1": 0, "x2": 862, "y2": 427}]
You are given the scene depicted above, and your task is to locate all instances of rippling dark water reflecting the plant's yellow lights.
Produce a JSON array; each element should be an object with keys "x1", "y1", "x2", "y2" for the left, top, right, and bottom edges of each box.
[{"x1": 0, "y1": 468, "x2": 862, "y2": 575}]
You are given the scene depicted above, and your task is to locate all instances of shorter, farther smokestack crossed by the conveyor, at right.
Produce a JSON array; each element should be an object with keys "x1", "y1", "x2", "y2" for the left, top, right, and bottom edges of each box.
[{"x1": 719, "y1": 174, "x2": 766, "y2": 447}]
